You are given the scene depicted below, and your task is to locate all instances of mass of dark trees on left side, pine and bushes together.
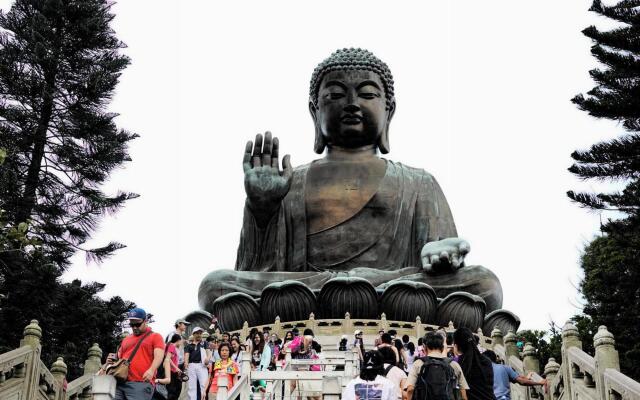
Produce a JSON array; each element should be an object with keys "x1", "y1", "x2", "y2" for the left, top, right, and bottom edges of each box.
[{"x1": 0, "y1": 0, "x2": 137, "y2": 380}]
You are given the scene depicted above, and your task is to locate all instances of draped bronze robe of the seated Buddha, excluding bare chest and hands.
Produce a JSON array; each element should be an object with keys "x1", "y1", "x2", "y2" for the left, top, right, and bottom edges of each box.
[{"x1": 198, "y1": 160, "x2": 502, "y2": 311}]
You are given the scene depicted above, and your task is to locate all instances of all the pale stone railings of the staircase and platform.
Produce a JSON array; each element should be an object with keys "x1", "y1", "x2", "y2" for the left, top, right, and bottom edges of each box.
[{"x1": 0, "y1": 314, "x2": 640, "y2": 400}]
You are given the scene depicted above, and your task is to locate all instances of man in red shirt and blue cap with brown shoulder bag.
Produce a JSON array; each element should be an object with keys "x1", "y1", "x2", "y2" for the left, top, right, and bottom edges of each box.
[{"x1": 115, "y1": 308, "x2": 164, "y2": 400}]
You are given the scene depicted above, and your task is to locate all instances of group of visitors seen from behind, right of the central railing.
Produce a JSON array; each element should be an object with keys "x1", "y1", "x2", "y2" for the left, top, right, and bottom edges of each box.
[{"x1": 341, "y1": 328, "x2": 546, "y2": 400}]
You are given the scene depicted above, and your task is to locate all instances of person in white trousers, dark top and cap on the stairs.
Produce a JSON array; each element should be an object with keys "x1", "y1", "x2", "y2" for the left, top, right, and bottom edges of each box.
[{"x1": 184, "y1": 326, "x2": 211, "y2": 400}]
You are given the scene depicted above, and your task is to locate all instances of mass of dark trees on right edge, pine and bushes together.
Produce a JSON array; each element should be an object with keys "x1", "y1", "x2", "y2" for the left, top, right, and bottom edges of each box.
[{"x1": 567, "y1": 0, "x2": 640, "y2": 379}]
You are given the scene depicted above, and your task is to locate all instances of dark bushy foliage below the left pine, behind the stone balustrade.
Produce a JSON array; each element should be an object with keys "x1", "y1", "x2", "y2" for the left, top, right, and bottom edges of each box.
[{"x1": 0, "y1": 250, "x2": 134, "y2": 380}]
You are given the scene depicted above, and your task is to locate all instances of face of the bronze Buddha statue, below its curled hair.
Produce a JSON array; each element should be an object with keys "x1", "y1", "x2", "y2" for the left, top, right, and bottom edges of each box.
[{"x1": 309, "y1": 70, "x2": 394, "y2": 148}]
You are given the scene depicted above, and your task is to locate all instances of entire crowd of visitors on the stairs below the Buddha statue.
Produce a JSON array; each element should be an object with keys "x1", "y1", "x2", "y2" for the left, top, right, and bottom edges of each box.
[{"x1": 104, "y1": 308, "x2": 546, "y2": 400}]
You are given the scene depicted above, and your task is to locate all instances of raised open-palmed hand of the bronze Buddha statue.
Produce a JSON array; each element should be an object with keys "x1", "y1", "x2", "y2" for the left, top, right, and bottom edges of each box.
[{"x1": 242, "y1": 132, "x2": 293, "y2": 220}]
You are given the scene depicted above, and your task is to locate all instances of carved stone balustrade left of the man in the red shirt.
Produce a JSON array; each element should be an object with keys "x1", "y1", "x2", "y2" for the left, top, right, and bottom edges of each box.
[{"x1": 0, "y1": 320, "x2": 102, "y2": 400}]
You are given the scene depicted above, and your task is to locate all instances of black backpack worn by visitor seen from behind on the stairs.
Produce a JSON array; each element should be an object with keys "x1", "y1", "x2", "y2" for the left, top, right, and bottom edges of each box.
[{"x1": 412, "y1": 357, "x2": 458, "y2": 400}]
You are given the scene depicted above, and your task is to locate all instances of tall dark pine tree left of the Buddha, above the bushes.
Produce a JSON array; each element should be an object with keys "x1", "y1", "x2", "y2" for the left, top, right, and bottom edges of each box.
[{"x1": 0, "y1": 0, "x2": 137, "y2": 268}]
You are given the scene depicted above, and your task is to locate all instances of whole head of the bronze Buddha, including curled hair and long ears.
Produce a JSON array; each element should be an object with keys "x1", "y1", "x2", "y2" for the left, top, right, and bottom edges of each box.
[{"x1": 309, "y1": 49, "x2": 396, "y2": 154}]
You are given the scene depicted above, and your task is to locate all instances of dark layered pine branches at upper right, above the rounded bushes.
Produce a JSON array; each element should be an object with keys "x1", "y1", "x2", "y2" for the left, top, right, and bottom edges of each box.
[{"x1": 568, "y1": 0, "x2": 640, "y2": 219}]
